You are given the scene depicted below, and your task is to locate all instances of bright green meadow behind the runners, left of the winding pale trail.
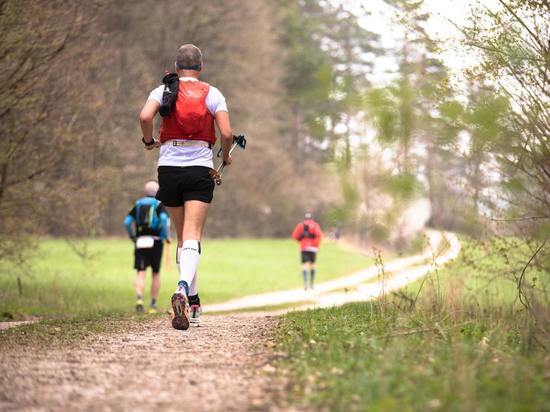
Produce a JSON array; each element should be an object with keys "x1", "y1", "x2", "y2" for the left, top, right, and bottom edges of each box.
[{"x1": 0, "y1": 239, "x2": 372, "y2": 319}]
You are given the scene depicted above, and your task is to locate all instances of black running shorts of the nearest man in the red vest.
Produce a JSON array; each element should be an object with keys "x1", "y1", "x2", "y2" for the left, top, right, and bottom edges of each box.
[{"x1": 156, "y1": 166, "x2": 214, "y2": 207}]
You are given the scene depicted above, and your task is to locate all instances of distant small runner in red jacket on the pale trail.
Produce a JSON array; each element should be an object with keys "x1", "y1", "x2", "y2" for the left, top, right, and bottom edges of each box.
[{"x1": 292, "y1": 213, "x2": 323, "y2": 290}]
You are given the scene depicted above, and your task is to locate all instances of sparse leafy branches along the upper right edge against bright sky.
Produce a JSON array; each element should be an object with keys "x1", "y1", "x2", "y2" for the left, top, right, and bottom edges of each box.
[{"x1": 464, "y1": 0, "x2": 550, "y2": 239}]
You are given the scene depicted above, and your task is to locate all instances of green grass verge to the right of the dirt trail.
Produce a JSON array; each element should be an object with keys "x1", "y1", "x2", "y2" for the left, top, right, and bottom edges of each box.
[{"x1": 277, "y1": 240, "x2": 550, "y2": 412}]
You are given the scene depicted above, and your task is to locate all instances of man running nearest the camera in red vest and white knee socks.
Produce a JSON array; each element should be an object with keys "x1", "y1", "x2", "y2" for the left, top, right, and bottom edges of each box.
[{"x1": 140, "y1": 44, "x2": 233, "y2": 330}]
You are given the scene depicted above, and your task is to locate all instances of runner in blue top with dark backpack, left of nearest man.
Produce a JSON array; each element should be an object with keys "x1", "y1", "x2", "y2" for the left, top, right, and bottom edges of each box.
[{"x1": 124, "y1": 180, "x2": 170, "y2": 313}]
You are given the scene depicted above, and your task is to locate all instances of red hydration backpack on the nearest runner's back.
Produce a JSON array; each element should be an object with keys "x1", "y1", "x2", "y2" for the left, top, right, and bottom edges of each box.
[{"x1": 160, "y1": 80, "x2": 216, "y2": 145}]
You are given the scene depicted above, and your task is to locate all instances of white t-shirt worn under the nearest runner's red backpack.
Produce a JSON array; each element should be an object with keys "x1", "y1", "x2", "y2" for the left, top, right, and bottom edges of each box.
[{"x1": 147, "y1": 77, "x2": 228, "y2": 168}]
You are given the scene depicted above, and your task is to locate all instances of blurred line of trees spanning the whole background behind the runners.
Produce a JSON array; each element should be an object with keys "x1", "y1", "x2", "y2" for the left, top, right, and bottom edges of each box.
[{"x1": 0, "y1": 0, "x2": 550, "y2": 259}]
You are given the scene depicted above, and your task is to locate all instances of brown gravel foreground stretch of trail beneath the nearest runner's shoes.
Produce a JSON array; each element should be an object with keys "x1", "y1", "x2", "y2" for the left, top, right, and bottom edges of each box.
[{"x1": 0, "y1": 314, "x2": 279, "y2": 412}]
